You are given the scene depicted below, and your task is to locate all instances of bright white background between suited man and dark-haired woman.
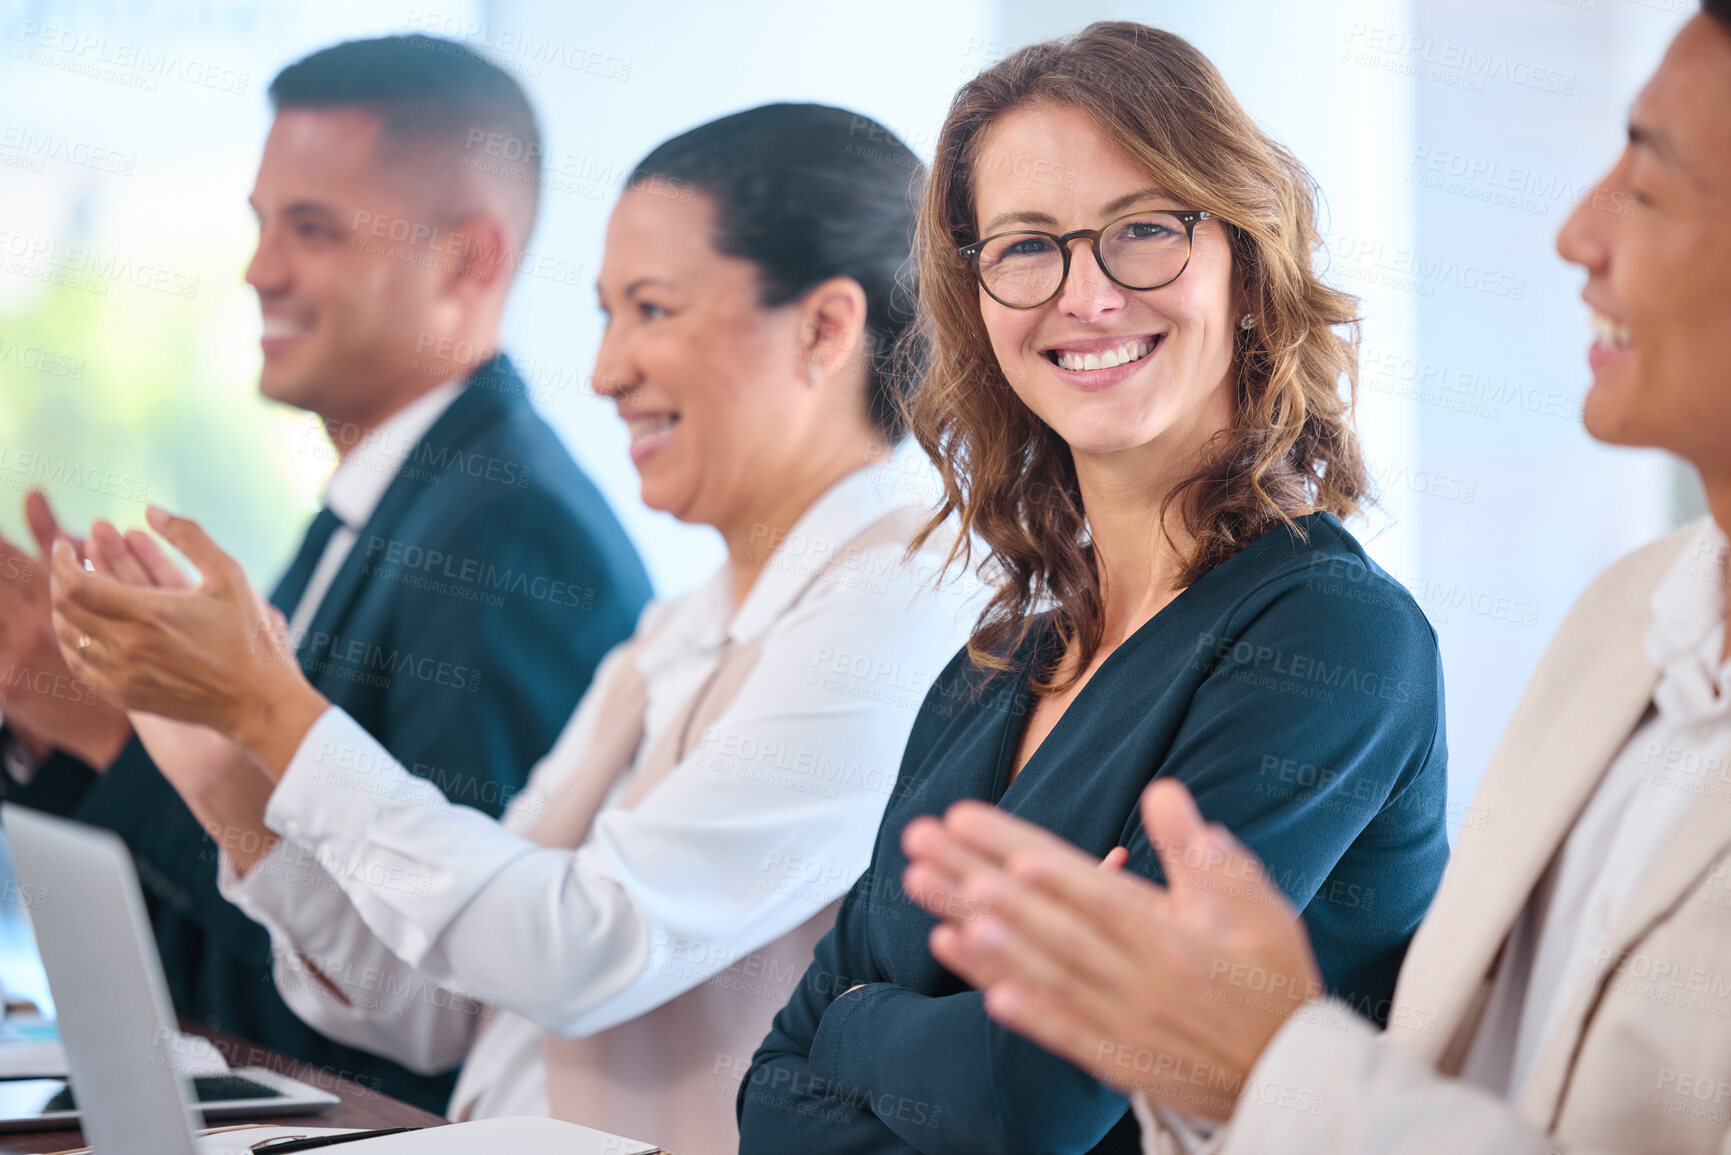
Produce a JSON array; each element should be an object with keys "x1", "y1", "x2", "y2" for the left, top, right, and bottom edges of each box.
[{"x1": 478, "y1": 0, "x2": 988, "y2": 594}]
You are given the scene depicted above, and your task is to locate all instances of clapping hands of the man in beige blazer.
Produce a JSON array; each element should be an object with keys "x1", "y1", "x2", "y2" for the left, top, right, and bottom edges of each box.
[{"x1": 902, "y1": 779, "x2": 1322, "y2": 1120}]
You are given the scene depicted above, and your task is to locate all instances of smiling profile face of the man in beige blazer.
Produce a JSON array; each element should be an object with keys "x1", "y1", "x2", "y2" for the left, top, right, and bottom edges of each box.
[{"x1": 1556, "y1": 16, "x2": 1731, "y2": 476}]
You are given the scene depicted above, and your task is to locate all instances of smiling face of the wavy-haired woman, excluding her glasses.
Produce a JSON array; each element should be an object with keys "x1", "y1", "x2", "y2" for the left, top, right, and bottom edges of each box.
[{"x1": 973, "y1": 102, "x2": 1234, "y2": 471}]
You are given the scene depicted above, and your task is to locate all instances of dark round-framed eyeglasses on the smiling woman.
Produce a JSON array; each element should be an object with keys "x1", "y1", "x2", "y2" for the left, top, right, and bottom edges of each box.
[{"x1": 959, "y1": 210, "x2": 1219, "y2": 308}]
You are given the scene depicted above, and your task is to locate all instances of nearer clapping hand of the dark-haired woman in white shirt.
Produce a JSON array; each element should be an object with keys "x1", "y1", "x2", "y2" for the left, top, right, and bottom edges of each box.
[{"x1": 54, "y1": 507, "x2": 327, "y2": 781}]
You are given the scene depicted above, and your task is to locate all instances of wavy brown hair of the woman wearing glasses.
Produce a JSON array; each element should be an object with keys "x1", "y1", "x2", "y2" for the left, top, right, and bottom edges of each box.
[{"x1": 909, "y1": 23, "x2": 1369, "y2": 691}]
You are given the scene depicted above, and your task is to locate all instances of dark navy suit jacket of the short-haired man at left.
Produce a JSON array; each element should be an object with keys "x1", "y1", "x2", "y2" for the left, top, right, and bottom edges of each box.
[{"x1": 21, "y1": 357, "x2": 649, "y2": 1112}]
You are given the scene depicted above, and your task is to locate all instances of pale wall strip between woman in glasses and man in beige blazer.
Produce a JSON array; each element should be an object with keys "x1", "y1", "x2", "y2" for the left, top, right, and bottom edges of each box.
[{"x1": 1383, "y1": 0, "x2": 1696, "y2": 800}]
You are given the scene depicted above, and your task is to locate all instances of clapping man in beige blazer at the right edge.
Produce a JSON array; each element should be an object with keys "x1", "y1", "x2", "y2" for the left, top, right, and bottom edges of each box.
[{"x1": 905, "y1": 0, "x2": 1731, "y2": 1155}]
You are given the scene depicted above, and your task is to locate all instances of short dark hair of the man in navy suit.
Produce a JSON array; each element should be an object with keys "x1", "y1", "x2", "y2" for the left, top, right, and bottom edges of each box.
[{"x1": 270, "y1": 33, "x2": 542, "y2": 241}]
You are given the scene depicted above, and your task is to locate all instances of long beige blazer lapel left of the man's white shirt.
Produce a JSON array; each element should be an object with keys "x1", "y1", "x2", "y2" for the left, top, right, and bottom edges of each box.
[{"x1": 1388, "y1": 585, "x2": 1658, "y2": 1074}]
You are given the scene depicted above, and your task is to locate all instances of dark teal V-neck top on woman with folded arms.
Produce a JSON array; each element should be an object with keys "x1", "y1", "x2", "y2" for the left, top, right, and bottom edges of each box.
[{"x1": 739, "y1": 514, "x2": 1449, "y2": 1155}]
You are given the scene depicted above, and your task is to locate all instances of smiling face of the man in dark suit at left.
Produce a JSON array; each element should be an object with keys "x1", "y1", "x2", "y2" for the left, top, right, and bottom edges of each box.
[{"x1": 246, "y1": 109, "x2": 450, "y2": 424}]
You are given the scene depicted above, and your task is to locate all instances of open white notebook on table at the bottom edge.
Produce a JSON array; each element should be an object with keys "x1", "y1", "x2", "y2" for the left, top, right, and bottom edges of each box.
[{"x1": 199, "y1": 1115, "x2": 661, "y2": 1155}]
